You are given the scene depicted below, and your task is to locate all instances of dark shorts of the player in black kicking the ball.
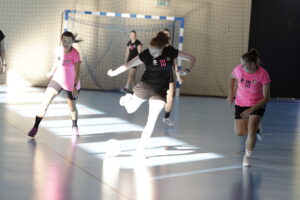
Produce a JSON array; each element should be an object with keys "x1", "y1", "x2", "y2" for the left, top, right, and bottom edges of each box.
[{"x1": 133, "y1": 81, "x2": 167, "y2": 102}]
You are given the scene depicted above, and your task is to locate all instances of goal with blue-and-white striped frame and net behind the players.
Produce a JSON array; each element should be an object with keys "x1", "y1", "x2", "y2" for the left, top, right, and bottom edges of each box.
[{"x1": 63, "y1": 10, "x2": 184, "y2": 96}]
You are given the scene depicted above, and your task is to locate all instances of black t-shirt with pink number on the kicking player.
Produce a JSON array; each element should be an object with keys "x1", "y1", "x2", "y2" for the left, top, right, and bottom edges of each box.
[{"x1": 139, "y1": 47, "x2": 178, "y2": 90}]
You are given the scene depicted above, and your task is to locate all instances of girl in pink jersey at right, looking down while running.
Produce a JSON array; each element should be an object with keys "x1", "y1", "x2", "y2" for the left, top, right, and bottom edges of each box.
[{"x1": 227, "y1": 49, "x2": 271, "y2": 167}]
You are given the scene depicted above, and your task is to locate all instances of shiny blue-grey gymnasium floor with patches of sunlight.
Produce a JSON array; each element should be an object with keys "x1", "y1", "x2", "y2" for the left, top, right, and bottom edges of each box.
[{"x1": 0, "y1": 86, "x2": 300, "y2": 200}]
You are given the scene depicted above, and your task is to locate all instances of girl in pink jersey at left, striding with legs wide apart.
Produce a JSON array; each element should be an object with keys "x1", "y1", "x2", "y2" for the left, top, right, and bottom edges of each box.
[{"x1": 28, "y1": 31, "x2": 81, "y2": 137}]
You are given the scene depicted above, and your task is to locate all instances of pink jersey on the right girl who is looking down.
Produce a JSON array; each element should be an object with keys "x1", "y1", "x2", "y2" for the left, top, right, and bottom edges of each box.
[{"x1": 232, "y1": 64, "x2": 271, "y2": 106}]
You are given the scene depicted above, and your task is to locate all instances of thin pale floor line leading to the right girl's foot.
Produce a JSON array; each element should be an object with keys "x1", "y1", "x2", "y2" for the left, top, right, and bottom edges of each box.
[{"x1": 153, "y1": 165, "x2": 242, "y2": 180}]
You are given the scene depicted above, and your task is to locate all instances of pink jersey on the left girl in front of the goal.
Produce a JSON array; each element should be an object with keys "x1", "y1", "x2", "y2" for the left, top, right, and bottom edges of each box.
[{"x1": 52, "y1": 46, "x2": 80, "y2": 91}]
